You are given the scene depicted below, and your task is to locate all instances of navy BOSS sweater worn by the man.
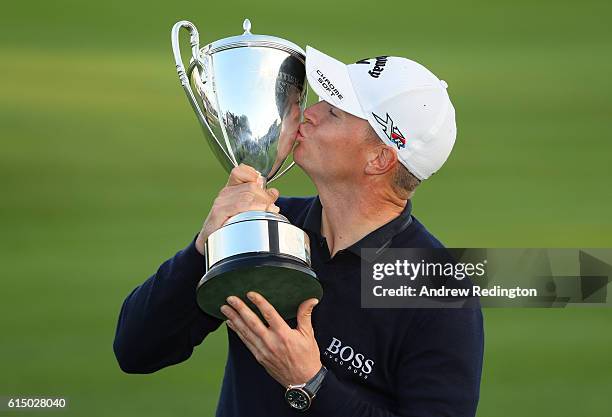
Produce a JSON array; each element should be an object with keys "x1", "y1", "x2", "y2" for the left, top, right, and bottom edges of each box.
[{"x1": 114, "y1": 198, "x2": 483, "y2": 417}]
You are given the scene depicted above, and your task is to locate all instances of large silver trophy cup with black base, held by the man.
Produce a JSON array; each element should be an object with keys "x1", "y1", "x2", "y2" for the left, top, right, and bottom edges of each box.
[{"x1": 172, "y1": 19, "x2": 323, "y2": 318}]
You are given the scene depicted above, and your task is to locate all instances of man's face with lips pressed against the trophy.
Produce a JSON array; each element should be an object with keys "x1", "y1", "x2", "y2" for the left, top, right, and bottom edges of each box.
[{"x1": 293, "y1": 101, "x2": 368, "y2": 180}]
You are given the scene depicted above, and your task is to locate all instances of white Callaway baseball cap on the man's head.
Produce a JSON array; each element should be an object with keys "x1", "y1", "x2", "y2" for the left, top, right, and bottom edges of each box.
[{"x1": 306, "y1": 46, "x2": 457, "y2": 180}]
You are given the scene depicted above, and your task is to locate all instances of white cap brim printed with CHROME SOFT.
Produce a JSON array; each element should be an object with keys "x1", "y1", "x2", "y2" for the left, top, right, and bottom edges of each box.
[{"x1": 306, "y1": 46, "x2": 367, "y2": 119}]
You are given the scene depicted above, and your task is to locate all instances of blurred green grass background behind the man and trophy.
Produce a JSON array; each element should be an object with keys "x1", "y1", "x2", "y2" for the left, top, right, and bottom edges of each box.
[{"x1": 0, "y1": 0, "x2": 612, "y2": 417}]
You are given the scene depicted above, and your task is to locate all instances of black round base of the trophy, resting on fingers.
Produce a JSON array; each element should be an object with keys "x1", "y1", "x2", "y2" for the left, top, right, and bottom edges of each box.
[{"x1": 197, "y1": 253, "x2": 323, "y2": 319}]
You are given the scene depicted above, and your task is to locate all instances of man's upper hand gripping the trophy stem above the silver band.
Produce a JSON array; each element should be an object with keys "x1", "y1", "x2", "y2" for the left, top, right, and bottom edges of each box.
[{"x1": 196, "y1": 164, "x2": 280, "y2": 255}]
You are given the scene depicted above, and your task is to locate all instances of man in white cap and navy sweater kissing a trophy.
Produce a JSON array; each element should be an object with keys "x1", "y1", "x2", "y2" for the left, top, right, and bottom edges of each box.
[{"x1": 114, "y1": 47, "x2": 483, "y2": 417}]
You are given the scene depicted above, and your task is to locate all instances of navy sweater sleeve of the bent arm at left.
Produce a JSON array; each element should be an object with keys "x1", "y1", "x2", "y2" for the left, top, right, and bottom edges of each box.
[{"x1": 113, "y1": 239, "x2": 222, "y2": 373}]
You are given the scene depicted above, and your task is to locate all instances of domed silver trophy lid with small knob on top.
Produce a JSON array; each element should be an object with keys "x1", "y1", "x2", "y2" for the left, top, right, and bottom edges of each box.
[{"x1": 203, "y1": 19, "x2": 306, "y2": 61}]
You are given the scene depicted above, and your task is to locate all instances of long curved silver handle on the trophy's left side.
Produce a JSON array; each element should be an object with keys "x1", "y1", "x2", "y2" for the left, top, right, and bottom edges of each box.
[{"x1": 170, "y1": 20, "x2": 236, "y2": 166}]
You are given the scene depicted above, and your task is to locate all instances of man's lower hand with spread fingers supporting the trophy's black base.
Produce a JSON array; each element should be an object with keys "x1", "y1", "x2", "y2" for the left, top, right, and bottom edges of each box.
[{"x1": 221, "y1": 291, "x2": 322, "y2": 387}]
